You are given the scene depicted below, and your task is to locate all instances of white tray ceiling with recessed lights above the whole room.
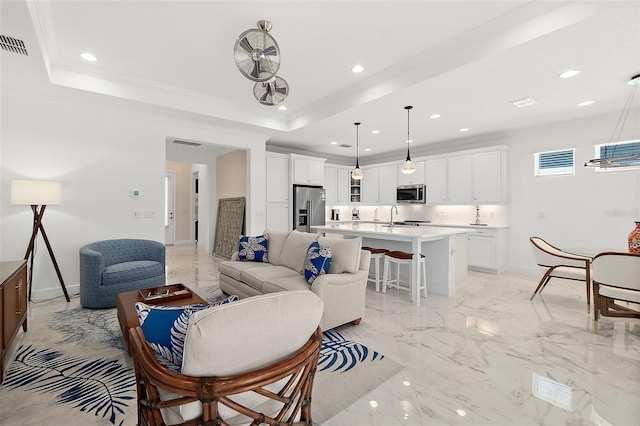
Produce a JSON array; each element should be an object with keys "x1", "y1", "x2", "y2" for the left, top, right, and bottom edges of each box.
[{"x1": 3, "y1": 0, "x2": 640, "y2": 162}]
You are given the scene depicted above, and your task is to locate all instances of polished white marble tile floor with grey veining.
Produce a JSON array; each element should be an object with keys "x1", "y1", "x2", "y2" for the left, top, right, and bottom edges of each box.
[{"x1": 167, "y1": 246, "x2": 640, "y2": 426}]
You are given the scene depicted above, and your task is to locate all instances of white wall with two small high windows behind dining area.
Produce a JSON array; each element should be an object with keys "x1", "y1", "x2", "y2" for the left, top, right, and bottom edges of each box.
[{"x1": 509, "y1": 110, "x2": 640, "y2": 272}]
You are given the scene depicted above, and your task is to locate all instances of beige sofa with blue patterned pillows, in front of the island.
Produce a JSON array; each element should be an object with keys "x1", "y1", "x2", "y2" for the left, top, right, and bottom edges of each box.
[{"x1": 220, "y1": 230, "x2": 371, "y2": 330}]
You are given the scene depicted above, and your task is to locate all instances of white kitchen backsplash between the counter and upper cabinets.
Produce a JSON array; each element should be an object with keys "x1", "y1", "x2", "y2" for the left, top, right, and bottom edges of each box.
[{"x1": 326, "y1": 204, "x2": 509, "y2": 225}]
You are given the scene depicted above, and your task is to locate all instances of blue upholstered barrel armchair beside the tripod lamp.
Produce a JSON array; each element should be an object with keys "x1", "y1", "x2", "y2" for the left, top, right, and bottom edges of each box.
[{"x1": 80, "y1": 239, "x2": 165, "y2": 308}]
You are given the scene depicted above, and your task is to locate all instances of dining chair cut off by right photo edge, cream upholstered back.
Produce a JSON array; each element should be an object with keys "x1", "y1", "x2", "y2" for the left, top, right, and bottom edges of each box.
[{"x1": 591, "y1": 252, "x2": 640, "y2": 321}]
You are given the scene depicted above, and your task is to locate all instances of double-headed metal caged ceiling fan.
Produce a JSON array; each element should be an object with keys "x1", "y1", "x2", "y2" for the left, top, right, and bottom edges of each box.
[{"x1": 233, "y1": 20, "x2": 289, "y2": 106}]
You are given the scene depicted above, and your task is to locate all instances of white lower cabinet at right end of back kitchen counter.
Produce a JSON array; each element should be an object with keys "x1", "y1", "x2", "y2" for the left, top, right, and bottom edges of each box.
[{"x1": 468, "y1": 229, "x2": 508, "y2": 274}]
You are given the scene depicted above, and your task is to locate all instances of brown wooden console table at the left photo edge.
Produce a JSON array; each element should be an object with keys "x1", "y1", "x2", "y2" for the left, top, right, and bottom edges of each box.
[{"x1": 0, "y1": 260, "x2": 27, "y2": 383}]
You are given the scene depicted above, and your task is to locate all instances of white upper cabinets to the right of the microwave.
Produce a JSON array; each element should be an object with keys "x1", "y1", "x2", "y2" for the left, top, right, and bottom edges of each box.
[{"x1": 425, "y1": 149, "x2": 507, "y2": 204}]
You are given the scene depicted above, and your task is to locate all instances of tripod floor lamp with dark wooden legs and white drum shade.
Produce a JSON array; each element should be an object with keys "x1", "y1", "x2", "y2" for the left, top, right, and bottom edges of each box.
[{"x1": 11, "y1": 180, "x2": 70, "y2": 302}]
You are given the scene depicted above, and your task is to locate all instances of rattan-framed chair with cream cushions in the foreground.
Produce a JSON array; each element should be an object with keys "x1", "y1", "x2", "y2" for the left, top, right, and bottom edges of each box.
[{"x1": 130, "y1": 291, "x2": 323, "y2": 425}]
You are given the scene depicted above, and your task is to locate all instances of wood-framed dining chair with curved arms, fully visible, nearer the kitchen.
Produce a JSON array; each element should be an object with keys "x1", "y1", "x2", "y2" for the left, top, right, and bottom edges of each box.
[{"x1": 529, "y1": 237, "x2": 591, "y2": 311}]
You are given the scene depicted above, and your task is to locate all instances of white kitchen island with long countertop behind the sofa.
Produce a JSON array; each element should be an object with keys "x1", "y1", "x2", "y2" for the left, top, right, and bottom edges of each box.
[{"x1": 311, "y1": 222, "x2": 472, "y2": 305}]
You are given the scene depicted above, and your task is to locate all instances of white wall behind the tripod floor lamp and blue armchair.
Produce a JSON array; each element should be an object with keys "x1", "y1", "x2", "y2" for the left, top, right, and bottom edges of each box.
[{"x1": 0, "y1": 91, "x2": 265, "y2": 300}]
